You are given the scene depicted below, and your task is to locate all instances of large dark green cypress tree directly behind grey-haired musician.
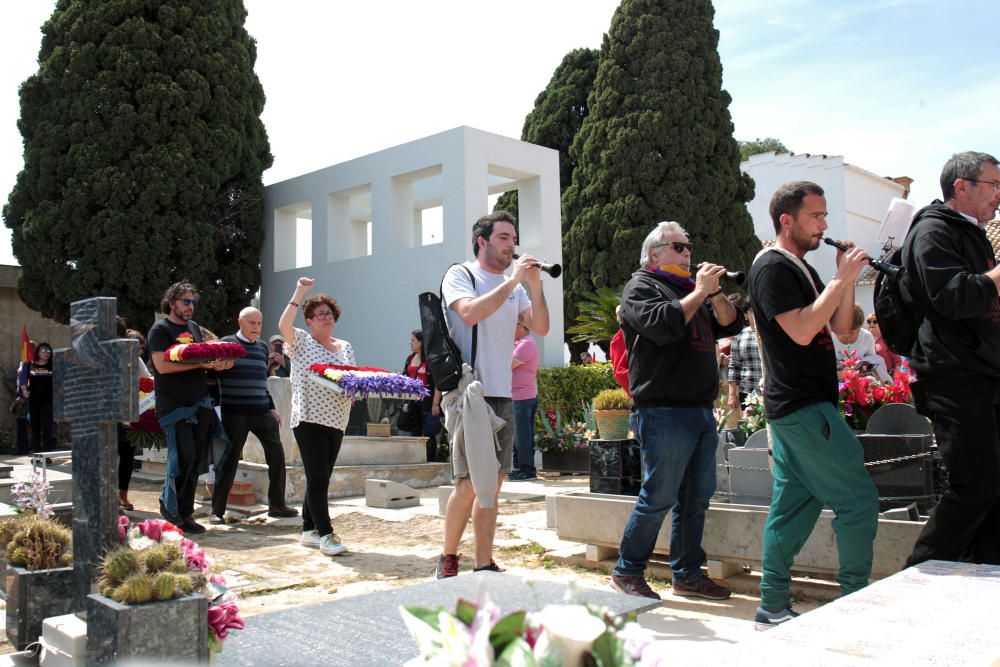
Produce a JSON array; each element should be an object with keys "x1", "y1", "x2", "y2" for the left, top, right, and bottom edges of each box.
[{"x1": 563, "y1": 0, "x2": 760, "y2": 320}]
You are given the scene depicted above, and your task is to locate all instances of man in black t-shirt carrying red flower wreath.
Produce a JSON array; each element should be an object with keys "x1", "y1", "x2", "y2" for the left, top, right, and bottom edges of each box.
[{"x1": 147, "y1": 282, "x2": 233, "y2": 534}]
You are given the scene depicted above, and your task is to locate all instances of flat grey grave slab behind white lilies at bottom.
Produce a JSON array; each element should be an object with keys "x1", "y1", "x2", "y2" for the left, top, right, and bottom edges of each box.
[{"x1": 219, "y1": 572, "x2": 659, "y2": 667}]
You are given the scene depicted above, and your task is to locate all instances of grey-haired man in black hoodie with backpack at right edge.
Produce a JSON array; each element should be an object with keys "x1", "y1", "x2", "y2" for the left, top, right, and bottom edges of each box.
[{"x1": 901, "y1": 152, "x2": 1000, "y2": 565}]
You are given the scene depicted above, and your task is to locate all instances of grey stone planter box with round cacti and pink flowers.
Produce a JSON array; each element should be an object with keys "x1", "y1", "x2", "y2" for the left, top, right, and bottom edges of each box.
[{"x1": 87, "y1": 517, "x2": 243, "y2": 663}]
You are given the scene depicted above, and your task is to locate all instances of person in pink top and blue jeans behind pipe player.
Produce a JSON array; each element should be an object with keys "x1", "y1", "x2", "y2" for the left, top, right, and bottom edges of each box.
[{"x1": 510, "y1": 316, "x2": 538, "y2": 479}]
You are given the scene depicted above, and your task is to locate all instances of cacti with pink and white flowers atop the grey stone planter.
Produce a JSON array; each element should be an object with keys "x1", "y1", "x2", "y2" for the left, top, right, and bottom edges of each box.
[{"x1": 110, "y1": 516, "x2": 244, "y2": 653}]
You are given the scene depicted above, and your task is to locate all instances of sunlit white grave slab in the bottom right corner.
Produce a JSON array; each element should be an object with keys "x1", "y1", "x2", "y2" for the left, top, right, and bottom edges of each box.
[{"x1": 716, "y1": 561, "x2": 1000, "y2": 667}]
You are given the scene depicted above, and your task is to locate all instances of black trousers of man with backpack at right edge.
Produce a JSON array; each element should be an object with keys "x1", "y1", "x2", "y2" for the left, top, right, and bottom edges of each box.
[{"x1": 906, "y1": 376, "x2": 1000, "y2": 566}]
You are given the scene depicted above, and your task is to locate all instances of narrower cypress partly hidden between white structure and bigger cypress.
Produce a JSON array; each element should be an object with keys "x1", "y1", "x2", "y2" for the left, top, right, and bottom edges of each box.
[{"x1": 494, "y1": 49, "x2": 601, "y2": 219}]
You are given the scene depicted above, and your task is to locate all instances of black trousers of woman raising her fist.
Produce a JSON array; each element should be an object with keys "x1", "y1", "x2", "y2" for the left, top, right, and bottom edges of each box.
[{"x1": 292, "y1": 422, "x2": 344, "y2": 537}]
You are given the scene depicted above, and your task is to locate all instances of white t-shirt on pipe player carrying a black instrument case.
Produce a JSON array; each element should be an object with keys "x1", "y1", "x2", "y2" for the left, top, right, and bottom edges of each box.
[{"x1": 441, "y1": 262, "x2": 531, "y2": 398}]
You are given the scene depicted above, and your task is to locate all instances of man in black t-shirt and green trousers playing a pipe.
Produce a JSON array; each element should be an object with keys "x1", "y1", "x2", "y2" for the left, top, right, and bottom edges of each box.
[{"x1": 750, "y1": 181, "x2": 878, "y2": 628}]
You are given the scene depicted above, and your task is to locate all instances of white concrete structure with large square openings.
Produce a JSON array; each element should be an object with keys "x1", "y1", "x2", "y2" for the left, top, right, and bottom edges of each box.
[{"x1": 261, "y1": 127, "x2": 563, "y2": 370}]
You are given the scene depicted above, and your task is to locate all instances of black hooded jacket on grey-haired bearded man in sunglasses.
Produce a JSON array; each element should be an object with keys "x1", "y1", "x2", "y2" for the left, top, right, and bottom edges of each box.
[{"x1": 622, "y1": 269, "x2": 745, "y2": 408}]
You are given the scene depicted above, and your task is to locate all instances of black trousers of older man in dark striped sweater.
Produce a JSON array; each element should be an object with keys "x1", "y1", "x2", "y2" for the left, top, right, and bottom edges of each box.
[{"x1": 212, "y1": 410, "x2": 285, "y2": 516}]
